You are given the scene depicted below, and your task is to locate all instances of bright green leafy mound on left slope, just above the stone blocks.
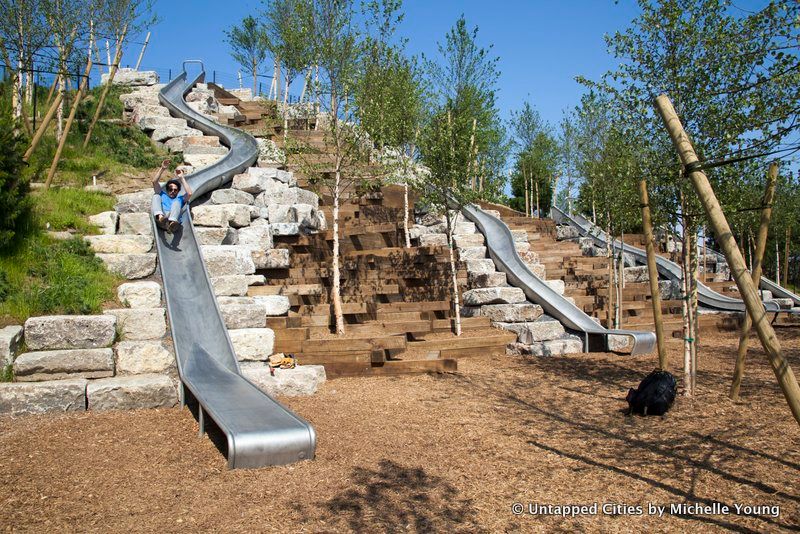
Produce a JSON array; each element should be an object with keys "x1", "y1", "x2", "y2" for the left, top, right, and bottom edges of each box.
[{"x1": 0, "y1": 234, "x2": 117, "y2": 322}]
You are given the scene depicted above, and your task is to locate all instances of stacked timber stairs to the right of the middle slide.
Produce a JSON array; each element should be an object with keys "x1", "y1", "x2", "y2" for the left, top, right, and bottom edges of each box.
[{"x1": 485, "y1": 204, "x2": 752, "y2": 343}]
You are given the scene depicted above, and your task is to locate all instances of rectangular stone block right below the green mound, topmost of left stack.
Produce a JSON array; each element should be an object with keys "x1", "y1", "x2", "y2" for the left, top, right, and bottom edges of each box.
[{"x1": 25, "y1": 315, "x2": 117, "y2": 350}]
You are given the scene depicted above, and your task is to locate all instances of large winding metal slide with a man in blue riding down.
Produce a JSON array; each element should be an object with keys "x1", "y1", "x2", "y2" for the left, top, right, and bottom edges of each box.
[{"x1": 153, "y1": 62, "x2": 316, "y2": 468}]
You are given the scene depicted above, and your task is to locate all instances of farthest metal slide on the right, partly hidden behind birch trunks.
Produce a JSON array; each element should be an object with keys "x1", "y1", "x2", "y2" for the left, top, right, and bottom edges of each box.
[{"x1": 550, "y1": 206, "x2": 780, "y2": 312}]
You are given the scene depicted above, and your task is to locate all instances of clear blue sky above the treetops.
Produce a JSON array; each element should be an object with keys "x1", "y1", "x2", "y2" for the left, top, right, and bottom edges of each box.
[{"x1": 114, "y1": 0, "x2": 637, "y2": 132}]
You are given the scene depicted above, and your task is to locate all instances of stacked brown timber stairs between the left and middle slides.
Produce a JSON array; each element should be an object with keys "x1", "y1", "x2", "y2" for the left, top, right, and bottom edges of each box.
[{"x1": 249, "y1": 131, "x2": 516, "y2": 377}]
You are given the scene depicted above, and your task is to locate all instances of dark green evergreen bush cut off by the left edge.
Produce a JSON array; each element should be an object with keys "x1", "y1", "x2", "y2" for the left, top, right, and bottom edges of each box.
[{"x1": 0, "y1": 105, "x2": 31, "y2": 250}]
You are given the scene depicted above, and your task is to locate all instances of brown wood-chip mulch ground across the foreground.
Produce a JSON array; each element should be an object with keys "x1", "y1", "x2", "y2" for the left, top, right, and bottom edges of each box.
[{"x1": 0, "y1": 328, "x2": 800, "y2": 532}]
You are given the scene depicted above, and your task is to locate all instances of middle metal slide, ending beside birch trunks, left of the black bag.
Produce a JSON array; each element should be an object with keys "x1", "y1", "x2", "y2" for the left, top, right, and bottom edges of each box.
[{"x1": 461, "y1": 205, "x2": 656, "y2": 354}]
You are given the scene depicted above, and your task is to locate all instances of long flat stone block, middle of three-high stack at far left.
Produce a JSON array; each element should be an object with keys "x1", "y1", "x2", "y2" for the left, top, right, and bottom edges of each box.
[{"x1": 14, "y1": 349, "x2": 114, "y2": 382}]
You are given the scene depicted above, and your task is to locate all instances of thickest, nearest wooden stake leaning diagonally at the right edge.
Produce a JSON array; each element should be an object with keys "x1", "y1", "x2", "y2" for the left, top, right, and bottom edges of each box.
[{"x1": 655, "y1": 95, "x2": 800, "y2": 424}]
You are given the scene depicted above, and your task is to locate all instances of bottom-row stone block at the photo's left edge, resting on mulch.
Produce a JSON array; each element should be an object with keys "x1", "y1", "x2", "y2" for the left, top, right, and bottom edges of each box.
[{"x1": 0, "y1": 379, "x2": 88, "y2": 415}]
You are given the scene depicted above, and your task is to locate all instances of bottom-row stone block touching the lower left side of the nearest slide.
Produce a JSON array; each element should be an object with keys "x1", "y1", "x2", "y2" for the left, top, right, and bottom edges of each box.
[{"x1": 86, "y1": 374, "x2": 178, "y2": 411}]
